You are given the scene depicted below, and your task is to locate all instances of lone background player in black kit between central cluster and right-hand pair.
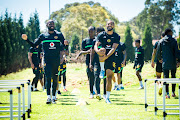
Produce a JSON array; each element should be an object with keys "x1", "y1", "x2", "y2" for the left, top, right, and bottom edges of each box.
[{"x1": 133, "y1": 40, "x2": 144, "y2": 89}]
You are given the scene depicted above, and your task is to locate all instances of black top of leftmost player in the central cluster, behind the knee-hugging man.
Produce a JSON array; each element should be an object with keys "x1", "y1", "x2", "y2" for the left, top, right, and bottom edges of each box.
[{"x1": 82, "y1": 38, "x2": 93, "y2": 65}]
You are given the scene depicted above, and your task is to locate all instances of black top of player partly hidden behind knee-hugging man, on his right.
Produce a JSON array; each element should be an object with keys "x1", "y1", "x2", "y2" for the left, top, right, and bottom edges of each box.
[{"x1": 115, "y1": 42, "x2": 126, "y2": 63}]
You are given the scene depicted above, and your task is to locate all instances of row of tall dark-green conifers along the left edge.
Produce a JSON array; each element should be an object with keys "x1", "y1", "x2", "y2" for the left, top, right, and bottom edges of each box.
[{"x1": 0, "y1": 10, "x2": 40, "y2": 76}]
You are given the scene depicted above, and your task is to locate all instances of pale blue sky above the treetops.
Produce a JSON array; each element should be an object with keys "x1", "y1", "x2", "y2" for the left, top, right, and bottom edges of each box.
[{"x1": 0, "y1": 0, "x2": 179, "y2": 35}]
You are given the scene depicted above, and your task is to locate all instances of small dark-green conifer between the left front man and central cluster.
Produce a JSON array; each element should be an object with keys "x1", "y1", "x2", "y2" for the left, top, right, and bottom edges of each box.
[{"x1": 70, "y1": 34, "x2": 80, "y2": 53}]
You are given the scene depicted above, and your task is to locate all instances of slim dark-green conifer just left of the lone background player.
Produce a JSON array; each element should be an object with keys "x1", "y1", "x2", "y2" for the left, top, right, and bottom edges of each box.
[{"x1": 125, "y1": 24, "x2": 134, "y2": 62}]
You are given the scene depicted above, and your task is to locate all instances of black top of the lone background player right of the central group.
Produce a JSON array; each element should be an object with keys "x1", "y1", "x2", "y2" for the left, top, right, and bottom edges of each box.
[{"x1": 135, "y1": 46, "x2": 144, "y2": 64}]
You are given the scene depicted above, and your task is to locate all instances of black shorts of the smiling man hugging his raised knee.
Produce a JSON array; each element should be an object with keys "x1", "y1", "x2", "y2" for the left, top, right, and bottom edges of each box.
[{"x1": 104, "y1": 57, "x2": 115, "y2": 70}]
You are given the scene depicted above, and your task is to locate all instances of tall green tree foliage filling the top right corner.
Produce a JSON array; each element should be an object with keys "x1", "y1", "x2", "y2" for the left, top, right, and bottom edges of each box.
[{"x1": 131, "y1": 0, "x2": 180, "y2": 39}]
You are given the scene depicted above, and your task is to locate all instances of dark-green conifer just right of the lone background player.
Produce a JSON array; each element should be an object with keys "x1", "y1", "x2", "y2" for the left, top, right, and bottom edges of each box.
[{"x1": 142, "y1": 24, "x2": 153, "y2": 61}]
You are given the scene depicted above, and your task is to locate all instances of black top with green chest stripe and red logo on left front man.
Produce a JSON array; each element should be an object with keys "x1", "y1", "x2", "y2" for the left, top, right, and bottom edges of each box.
[{"x1": 27, "y1": 30, "x2": 65, "y2": 59}]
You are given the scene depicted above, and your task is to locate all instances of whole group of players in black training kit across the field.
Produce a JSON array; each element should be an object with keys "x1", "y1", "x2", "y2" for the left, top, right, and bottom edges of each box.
[{"x1": 22, "y1": 20, "x2": 178, "y2": 104}]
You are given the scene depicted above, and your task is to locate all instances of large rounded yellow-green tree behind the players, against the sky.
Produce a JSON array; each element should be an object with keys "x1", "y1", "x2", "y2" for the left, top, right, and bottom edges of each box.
[{"x1": 51, "y1": 1, "x2": 119, "y2": 47}]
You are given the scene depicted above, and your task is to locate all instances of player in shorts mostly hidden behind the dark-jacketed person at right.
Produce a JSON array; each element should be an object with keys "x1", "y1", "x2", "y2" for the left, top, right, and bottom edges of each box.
[{"x1": 151, "y1": 33, "x2": 165, "y2": 95}]
